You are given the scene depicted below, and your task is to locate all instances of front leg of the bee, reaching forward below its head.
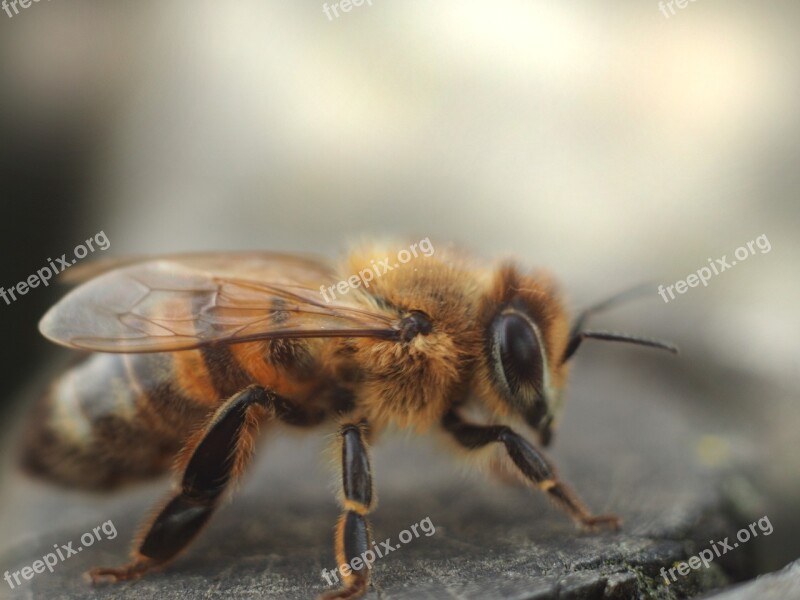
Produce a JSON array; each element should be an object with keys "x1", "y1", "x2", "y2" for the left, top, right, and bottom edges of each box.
[{"x1": 442, "y1": 412, "x2": 622, "y2": 529}]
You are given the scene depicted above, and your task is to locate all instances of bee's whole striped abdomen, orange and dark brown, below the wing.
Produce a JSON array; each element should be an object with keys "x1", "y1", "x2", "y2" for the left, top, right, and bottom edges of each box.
[{"x1": 23, "y1": 341, "x2": 321, "y2": 489}]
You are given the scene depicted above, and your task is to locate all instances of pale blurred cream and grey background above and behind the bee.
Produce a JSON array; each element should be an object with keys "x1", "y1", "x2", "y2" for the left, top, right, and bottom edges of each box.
[{"x1": 0, "y1": 0, "x2": 800, "y2": 596}]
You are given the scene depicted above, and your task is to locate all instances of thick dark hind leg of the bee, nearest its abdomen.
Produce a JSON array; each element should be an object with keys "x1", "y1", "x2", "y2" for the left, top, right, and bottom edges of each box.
[{"x1": 87, "y1": 386, "x2": 285, "y2": 583}]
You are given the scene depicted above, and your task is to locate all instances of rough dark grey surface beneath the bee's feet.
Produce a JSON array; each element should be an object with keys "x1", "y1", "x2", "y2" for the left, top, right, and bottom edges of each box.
[{"x1": 0, "y1": 349, "x2": 794, "y2": 600}]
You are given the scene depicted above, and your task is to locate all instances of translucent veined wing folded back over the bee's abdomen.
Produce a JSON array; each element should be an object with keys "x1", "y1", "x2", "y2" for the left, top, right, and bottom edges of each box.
[{"x1": 39, "y1": 252, "x2": 396, "y2": 352}]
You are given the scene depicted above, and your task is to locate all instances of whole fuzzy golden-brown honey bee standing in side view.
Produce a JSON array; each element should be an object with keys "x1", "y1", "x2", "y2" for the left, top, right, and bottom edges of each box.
[{"x1": 23, "y1": 244, "x2": 676, "y2": 599}]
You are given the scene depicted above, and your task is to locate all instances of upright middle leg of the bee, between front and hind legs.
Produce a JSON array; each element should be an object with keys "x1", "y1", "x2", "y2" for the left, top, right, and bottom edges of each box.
[{"x1": 320, "y1": 424, "x2": 375, "y2": 600}]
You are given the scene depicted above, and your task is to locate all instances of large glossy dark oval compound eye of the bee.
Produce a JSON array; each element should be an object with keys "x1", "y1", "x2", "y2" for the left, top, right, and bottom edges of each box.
[{"x1": 493, "y1": 312, "x2": 544, "y2": 399}]
